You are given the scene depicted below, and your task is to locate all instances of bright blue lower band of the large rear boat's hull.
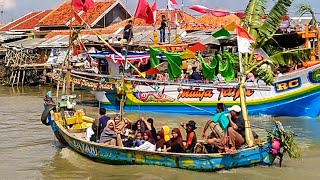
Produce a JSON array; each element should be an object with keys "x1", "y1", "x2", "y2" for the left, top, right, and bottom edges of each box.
[{"x1": 101, "y1": 91, "x2": 320, "y2": 118}]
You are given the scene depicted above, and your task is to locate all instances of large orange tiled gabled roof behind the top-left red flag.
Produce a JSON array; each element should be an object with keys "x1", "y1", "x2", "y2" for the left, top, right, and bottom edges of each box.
[{"x1": 38, "y1": 0, "x2": 119, "y2": 26}]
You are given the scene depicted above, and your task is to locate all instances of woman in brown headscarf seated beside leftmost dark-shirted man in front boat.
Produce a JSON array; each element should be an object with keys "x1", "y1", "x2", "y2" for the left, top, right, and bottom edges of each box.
[{"x1": 99, "y1": 120, "x2": 118, "y2": 146}]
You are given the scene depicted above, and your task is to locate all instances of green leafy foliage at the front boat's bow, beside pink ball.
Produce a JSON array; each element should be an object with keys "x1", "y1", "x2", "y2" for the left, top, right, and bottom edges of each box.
[{"x1": 267, "y1": 122, "x2": 301, "y2": 159}]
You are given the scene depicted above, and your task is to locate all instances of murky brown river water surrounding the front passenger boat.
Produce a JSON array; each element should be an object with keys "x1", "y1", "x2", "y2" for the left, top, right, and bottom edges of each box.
[{"x1": 0, "y1": 86, "x2": 320, "y2": 180}]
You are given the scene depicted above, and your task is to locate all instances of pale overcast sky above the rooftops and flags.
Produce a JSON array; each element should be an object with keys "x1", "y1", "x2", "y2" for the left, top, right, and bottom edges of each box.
[{"x1": 0, "y1": 0, "x2": 320, "y2": 23}]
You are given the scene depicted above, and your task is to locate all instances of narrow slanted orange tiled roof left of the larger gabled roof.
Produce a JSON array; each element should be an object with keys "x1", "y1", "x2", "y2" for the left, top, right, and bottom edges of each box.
[{"x1": 10, "y1": 10, "x2": 52, "y2": 30}]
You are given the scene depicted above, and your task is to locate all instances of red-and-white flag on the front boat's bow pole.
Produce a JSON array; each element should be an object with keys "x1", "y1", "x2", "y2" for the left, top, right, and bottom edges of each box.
[{"x1": 236, "y1": 25, "x2": 255, "y2": 53}]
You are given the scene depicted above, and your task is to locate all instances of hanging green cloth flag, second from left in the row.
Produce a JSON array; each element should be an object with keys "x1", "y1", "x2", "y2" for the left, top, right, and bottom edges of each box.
[{"x1": 164, "y1": 51, "x2": 182, "y2": 80}]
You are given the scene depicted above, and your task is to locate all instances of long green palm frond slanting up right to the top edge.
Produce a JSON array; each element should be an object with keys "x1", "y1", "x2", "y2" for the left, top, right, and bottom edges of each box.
[{"x1": 256, "y1": 0, "x2": 293, "y2": 48}]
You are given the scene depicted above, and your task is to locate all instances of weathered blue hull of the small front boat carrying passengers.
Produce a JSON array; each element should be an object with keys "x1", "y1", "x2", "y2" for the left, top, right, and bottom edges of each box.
[{"x1": 56, "y1": 120, "x2": 275, "y2": 171}]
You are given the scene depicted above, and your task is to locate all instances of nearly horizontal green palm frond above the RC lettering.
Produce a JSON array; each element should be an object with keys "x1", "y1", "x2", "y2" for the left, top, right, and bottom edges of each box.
[{"x1": 269, "y1": 48, "x2": 312, "y2": 65}]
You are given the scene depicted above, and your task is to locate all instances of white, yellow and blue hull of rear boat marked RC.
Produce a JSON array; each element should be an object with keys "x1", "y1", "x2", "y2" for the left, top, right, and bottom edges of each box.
[{"x1": 101, "y1": 65, "x2": 320, "y2": 118}]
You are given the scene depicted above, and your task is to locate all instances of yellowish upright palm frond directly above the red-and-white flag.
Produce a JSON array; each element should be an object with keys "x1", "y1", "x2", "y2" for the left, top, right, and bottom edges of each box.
[{"x1": 243, "y1": 0, "x2": 266, "y2": 38}]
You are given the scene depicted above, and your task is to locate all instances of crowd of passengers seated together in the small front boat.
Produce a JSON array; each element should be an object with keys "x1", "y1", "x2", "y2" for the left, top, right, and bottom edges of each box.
[{"x1": 86, "y1": 103, "x2": 257, "y2": 153}]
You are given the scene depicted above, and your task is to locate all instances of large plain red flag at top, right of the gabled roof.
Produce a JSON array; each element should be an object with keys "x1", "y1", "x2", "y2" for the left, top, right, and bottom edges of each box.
[{"x1": 134, "y1": 0, "x2": 154, "y2": 24}]
